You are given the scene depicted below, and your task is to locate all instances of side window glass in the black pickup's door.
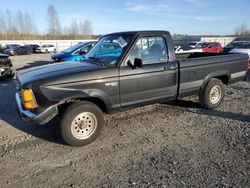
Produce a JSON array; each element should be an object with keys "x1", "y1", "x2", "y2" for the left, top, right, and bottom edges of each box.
[{"x1": 126, "y1": 36, "x2": 168, "y2": 64}]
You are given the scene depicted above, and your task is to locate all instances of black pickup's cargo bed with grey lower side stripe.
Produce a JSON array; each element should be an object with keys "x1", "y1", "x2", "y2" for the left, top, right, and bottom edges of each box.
[{"x1": 178, "y1": 53, "x2": 248, "y2": 96}]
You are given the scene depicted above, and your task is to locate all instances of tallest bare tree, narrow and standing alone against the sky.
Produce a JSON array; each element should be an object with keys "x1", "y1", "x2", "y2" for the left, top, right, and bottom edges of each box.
[{"x1": 47, "y1": 5, "x2": 61, "y2": 36}]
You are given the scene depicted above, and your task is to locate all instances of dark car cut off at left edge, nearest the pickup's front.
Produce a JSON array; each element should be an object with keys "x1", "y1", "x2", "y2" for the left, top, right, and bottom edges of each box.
[{"x1": 0, "y1": 54, "x2": 15, "y2": 78}]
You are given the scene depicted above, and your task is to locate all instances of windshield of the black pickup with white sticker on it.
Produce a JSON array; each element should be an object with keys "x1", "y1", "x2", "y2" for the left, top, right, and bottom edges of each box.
[{"x1": 86, "y1": 35, "x2": 132, "y2": 64}]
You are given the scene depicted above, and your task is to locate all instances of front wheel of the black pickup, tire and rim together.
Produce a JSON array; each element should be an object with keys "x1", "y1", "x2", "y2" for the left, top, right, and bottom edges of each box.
[{"x1": 60, "y1": 101, "x2": 104, "y2": 146}]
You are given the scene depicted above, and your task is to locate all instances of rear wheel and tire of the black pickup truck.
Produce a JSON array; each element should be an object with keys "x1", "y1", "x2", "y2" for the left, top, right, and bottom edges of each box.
[{"x1": 199, "y1": 78, "x2": 225, "y2": 109}]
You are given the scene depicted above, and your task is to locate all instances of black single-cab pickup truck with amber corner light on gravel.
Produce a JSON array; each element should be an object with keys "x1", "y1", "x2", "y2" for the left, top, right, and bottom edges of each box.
[{"x1": 16, "y1": 31, "x2": 248, "y2": 146}]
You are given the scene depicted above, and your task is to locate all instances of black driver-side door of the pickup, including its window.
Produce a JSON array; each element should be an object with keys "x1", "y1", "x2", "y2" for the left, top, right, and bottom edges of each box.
[{"x1": 120, "y1": 36, "x2": 177, "y2": 107}]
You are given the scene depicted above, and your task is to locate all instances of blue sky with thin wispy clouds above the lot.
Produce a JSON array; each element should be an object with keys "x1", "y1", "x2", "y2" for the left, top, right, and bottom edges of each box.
[{"x1": 0, "y1": 0, "x2": 250, "y2": 35}]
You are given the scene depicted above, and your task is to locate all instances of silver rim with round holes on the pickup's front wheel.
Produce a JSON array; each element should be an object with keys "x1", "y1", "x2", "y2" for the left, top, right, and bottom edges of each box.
[{"x1": 71, "y1": 112, "x2": 97, "y2": 140}]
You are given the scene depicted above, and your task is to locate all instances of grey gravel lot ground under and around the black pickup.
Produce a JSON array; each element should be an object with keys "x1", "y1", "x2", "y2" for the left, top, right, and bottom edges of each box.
[{"x1": 0, "y1": 54, "x2": 250, "y2": 187}]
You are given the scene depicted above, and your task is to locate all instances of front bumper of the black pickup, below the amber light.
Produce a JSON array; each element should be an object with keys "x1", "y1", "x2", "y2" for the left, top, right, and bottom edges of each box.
[{"x1": 16, "y1": 93, "x2": 58, "y2": 125}]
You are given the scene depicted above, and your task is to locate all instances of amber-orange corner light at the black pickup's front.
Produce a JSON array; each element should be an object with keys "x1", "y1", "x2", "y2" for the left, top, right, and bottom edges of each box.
[{"x1": 21, "y1": 89, "x2": 38, "y2": 109}]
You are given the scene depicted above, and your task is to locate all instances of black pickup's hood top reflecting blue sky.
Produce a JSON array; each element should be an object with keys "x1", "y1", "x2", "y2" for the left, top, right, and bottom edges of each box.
[{"x1": 17, "y1": 62, "x2": 103, "y2": 85}]
